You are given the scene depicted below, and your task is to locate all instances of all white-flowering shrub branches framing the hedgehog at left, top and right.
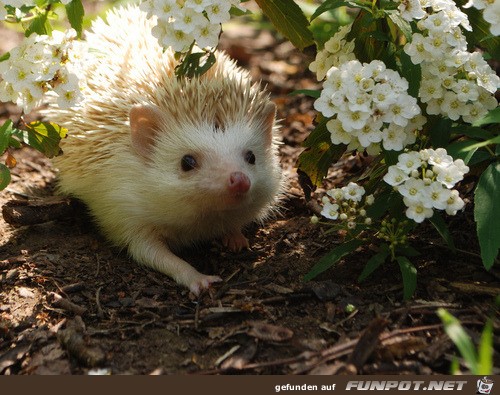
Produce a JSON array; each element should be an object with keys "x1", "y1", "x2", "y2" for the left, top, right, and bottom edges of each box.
[{"x1": 0, "y1": 0, "x2": 500, "y2": 298}]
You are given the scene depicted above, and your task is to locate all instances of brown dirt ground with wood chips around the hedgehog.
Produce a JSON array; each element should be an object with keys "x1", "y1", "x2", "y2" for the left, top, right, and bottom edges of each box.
[{"x1": 0, "y1": 15, "x2": 500, "y2": 375}]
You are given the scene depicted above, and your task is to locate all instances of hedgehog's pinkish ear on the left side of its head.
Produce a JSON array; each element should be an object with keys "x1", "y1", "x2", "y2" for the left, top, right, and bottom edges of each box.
[{"x1": 130, "y1": 104, "x2": 161, "y2": 158}]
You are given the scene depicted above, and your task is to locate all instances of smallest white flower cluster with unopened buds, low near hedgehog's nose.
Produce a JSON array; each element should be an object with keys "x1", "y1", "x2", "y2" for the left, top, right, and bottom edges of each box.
[{"x1": 321, "y1": 182, "x2": 374, "y2": 229}]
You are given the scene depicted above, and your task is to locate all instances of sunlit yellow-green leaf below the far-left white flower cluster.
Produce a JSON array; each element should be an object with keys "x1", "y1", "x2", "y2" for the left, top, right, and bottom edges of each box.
[{"x1": 15, "y1": 121, "x2": 68, "y2": 158}]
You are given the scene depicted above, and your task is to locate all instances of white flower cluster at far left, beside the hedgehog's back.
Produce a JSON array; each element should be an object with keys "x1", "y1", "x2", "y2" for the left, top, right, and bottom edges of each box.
[{"x1": 0, "y1": 29, "x2": 83, "y2": 113}]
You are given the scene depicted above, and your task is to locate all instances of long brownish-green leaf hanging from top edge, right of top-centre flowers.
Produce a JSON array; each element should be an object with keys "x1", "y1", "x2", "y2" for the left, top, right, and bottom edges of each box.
[{"x1": 256, "y1": 0, "x2": 314, "y2": 50}]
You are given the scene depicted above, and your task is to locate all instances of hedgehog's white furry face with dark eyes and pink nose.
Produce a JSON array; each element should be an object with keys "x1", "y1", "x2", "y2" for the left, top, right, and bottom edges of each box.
[{"x1": 131, "y1": 105, "x2": 281, "y2": 221}]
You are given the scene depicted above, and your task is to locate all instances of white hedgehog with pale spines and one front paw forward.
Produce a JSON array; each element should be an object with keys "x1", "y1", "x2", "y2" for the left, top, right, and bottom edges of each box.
[{"x1": 45, "y1": 7, "x2": 282, "y2": 294}]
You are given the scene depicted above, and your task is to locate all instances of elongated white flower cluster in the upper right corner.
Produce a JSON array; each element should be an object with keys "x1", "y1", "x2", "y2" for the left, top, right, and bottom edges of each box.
[{"x1": 399, "y1": 0, "x2": 500, "y2": 123}]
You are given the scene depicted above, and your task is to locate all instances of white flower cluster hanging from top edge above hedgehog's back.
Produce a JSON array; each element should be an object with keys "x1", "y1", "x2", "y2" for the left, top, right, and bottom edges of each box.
[{"x1": 140, "y1": 0, "x2": 243, "y2": 52}]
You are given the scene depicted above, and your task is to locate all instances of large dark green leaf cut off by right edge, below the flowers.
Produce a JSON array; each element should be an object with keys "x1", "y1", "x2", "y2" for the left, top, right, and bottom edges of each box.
[{"x1": 474, "y1": 162, "x2": 500, "y2": 270}]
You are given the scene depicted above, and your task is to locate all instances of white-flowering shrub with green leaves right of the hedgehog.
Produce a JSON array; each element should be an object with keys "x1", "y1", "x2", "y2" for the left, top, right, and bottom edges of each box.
[{"x1": 299, "y1": 0, "x2": 500, "y2": 298}]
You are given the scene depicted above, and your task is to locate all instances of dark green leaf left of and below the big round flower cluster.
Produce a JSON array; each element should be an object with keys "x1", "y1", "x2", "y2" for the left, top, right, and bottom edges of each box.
[{"x1": 297, "y1": 119, "x2": 346, "y2": 186}]
